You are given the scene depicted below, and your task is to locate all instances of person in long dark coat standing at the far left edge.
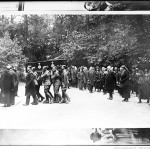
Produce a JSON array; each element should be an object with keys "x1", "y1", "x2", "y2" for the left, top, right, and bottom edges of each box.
[{"x1": 1, "y1": 65, "x2": 15, "y2": 107}]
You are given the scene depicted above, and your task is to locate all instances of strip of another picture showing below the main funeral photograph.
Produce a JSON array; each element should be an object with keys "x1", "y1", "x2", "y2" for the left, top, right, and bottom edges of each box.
[{"x1": 0, "y1": 128, "x2": 150, "y2": 146}]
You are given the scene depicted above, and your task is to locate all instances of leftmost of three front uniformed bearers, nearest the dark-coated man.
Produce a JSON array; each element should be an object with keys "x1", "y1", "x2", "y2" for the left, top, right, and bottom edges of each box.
[{"x1": 41, "y1": 66, "x2": 53, "y2": 104}]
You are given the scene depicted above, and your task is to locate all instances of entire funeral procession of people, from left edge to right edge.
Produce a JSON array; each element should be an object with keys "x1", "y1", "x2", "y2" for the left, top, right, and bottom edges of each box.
[{"x1": 0, "y1": 64, "x2": 150, "y2": 107}]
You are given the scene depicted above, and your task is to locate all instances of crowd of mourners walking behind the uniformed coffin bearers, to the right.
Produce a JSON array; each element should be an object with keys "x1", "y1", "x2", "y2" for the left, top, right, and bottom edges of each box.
[{"x1": 68, "y1": 65, "x2": 150, "y2": 103}]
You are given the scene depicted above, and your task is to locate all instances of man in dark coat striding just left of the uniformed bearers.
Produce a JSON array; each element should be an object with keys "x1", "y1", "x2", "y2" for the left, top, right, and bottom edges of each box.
[{"x1": 24, "y1": 67, "x2": 38, "y2": 106}]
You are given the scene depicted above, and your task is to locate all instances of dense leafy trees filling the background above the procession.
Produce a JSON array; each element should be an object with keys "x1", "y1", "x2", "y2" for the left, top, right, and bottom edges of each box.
[{"x1": 0, "y1": 15, "x2": 150, "y2": 68}]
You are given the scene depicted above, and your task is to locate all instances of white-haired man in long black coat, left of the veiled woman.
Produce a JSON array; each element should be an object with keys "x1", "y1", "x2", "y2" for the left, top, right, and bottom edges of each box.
[{"x1": 105, "y1": 66, "x2": 116, "y2": 100}]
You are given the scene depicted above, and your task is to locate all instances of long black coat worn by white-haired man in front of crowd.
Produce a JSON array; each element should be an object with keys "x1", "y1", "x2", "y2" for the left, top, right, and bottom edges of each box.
[{"x1": 105, "y1": 71, "x2": 116, "y2": 92}]
